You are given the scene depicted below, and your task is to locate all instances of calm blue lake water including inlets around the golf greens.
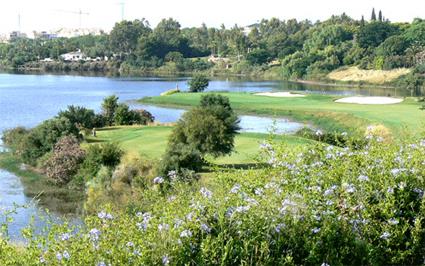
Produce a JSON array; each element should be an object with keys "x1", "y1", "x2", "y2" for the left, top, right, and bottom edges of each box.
[{"x1": 0, "y1": 74, "x2": 408, "y2": 239}]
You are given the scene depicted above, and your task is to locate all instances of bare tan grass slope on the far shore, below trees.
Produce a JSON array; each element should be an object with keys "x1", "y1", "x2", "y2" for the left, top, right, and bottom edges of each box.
[{"x1": 328, "y1": 67, "x2": 410, "y2": 84}]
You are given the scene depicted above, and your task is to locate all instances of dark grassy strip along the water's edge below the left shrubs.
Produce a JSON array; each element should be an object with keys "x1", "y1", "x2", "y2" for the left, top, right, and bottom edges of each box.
[{"x1": 0, "y1": 153, "x2": 84, "y2": 214}]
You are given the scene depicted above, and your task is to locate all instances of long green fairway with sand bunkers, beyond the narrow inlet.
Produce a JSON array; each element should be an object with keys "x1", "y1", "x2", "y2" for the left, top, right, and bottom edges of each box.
[{"x1": 140, "y1": 92, "x2": 425, "y2": 135}]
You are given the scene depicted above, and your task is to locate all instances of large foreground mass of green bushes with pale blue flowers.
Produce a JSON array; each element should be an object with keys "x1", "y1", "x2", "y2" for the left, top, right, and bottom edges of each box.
[{"x1": 0, "y1": 138, "x2": 425, "y2": 265}]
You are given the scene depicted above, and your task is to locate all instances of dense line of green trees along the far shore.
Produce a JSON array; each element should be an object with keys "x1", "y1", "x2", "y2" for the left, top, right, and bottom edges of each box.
[{"x1": 0, "y1": 10, "x2": 425, "y2": 79}]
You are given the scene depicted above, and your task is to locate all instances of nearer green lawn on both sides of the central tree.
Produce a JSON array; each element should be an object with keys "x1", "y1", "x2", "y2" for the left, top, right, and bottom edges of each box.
[{"x1": 88, "y1": 126, "x2": 311, "y2": 164}]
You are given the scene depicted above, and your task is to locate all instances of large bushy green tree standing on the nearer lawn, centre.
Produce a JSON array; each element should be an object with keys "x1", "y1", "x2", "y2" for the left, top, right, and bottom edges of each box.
[{"x1": 160, "y1": 94, "x2": 240, "y2": 174}]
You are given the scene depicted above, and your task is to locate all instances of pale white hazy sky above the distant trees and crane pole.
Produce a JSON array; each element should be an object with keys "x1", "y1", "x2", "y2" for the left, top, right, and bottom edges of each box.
[{"x1": 0, "y1": 0, "x2": 425, "y2": 32}]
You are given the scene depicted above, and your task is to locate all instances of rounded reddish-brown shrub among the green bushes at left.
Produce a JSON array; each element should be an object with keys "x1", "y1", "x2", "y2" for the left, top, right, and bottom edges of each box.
[{"x1": 43, "y1": 136, "x2": 84, "y2": 184}]
